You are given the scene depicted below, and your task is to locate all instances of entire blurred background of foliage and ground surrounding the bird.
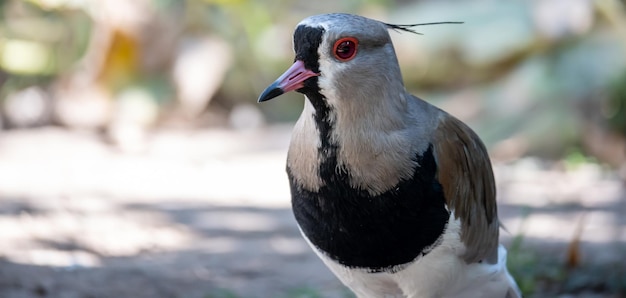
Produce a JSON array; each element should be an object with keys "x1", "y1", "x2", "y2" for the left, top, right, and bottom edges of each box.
[{"x1": 0, "y1": 0, "x2": 626, "y2": 298}]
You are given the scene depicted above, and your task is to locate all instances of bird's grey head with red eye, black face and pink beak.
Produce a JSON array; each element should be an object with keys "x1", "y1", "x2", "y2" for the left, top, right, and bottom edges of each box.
[{"x1": 259, "y1": 14, "x2": 406, "y2": 110}]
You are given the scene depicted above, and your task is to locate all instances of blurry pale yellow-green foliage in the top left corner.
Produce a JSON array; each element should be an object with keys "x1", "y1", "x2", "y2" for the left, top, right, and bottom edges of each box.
[{"x1": 0, "y1": 0, "x2": 92, "y2": 76}]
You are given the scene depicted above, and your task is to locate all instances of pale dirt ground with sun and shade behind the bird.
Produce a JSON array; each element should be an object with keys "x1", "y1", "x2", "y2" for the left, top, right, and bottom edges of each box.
[{"x1": 0, "y1": 126, "x2": 626, "y2": 298}]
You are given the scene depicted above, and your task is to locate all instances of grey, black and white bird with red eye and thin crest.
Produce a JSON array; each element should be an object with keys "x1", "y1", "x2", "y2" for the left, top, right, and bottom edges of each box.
[{"x1": 258, "y1": 13, "x2": 521, "y2": 298}]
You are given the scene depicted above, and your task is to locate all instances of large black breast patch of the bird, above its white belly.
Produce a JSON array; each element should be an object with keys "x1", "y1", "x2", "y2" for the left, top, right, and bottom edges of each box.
[{"x1": 287, "y1": 144, "x2": 450, "y2": 272}]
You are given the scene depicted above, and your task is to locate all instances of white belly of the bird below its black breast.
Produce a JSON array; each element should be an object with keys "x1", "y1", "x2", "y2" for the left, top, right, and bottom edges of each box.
[{"x1": 305, "y1": 215, "x2": 521, "y2": 298}]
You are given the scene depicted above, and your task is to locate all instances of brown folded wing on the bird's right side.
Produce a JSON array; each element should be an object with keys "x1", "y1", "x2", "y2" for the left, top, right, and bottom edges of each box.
[{"x1": 434, "y1": 114, "x2": 499, "y2": 263}]
